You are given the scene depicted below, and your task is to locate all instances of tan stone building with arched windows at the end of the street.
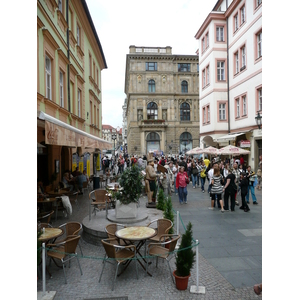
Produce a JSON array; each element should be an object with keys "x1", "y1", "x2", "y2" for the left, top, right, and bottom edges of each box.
[{"x1": 125, "y1": 46, "x2": 199, "y2": 154}]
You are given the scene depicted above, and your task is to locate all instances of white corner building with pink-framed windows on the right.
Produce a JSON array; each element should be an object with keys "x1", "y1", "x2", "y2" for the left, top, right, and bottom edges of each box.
[{"x1": 195, "y1": 0, "x2": 262, "y2": 169}]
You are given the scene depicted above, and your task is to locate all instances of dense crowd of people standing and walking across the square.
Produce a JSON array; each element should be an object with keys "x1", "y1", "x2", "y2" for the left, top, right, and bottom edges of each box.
[{"x1": 120, "y1": 155, "x2": 262, "y2": 212}]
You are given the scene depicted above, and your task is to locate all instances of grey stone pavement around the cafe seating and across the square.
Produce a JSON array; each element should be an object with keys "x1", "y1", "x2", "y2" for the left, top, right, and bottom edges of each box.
[{"x1": 37, "y1": 179, "x2": 262, "y2": 300}]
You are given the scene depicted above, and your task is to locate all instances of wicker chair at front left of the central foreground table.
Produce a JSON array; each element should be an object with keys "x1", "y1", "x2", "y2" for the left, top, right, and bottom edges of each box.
[{"x1": 99, "y1": 239, "x2": 138, "y2": 291}]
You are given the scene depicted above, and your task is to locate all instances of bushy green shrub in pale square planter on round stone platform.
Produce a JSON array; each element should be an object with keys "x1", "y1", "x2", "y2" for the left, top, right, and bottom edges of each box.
[{"x1": 115, "y1": 165, "x2": 143, "y2": 218}]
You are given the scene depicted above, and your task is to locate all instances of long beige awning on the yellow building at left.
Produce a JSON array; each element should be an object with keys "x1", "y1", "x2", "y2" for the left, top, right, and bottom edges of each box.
[{"x1": 37, "y1": 111, "x2": 112, "y2": 150}]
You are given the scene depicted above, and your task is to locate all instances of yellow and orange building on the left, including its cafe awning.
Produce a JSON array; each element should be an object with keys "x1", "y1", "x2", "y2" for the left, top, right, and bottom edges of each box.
[{"x1": 37, "y1": 0, "x2": 111, "y2": 184}]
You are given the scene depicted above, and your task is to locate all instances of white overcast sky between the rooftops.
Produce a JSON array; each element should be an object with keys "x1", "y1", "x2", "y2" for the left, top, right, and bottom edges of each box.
[{"x1": 86, "y1": 0, "x2": 217, "y2": 127}]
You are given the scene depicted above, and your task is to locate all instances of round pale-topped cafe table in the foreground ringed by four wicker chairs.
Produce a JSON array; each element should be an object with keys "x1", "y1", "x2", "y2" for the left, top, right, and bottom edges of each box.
[{"x1": 115, "y1": 226, "x2": 157, "y2": 276}]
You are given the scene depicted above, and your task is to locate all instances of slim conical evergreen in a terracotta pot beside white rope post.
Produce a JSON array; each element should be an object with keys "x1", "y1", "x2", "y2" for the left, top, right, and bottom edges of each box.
[{"x1": 173, "y1": 222, "x2": 196, "y2": 290}]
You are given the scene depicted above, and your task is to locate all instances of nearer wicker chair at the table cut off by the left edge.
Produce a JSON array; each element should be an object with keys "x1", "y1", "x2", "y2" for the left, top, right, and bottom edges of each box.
[{"x1": 47, "y1": 235, "x2": 82, "y2": 284}]
